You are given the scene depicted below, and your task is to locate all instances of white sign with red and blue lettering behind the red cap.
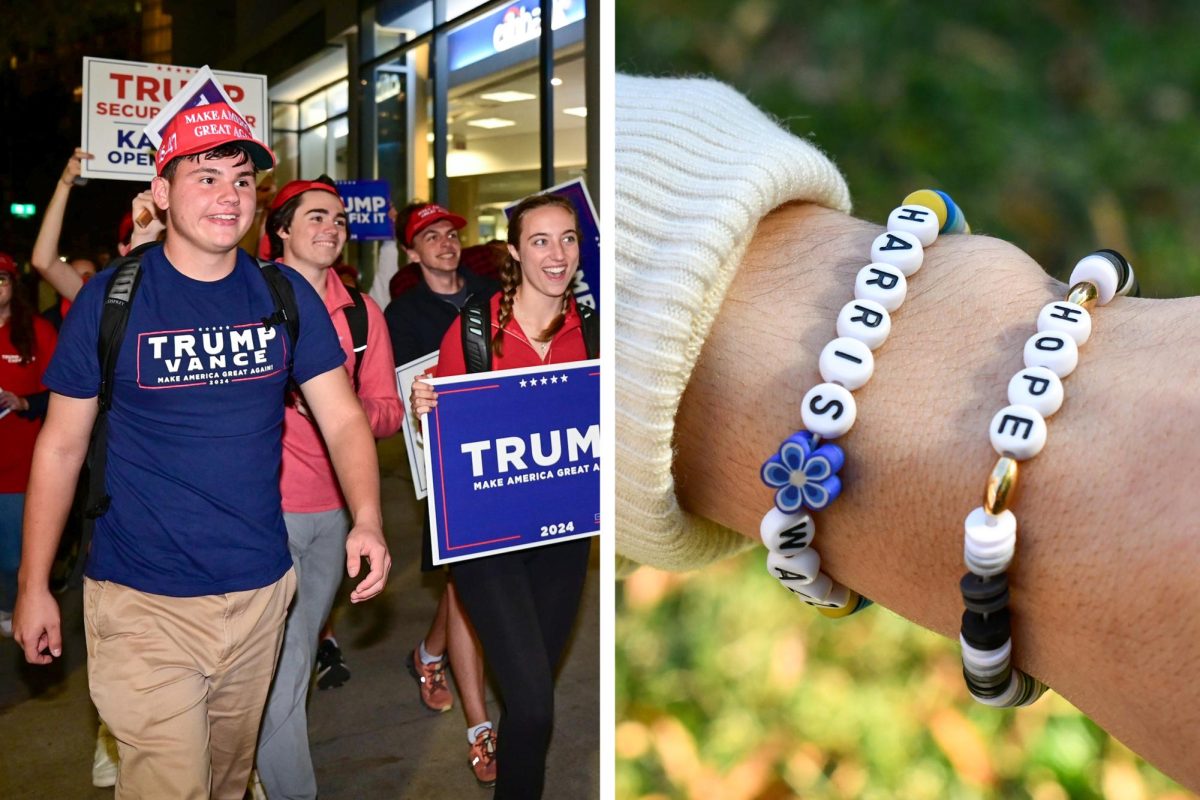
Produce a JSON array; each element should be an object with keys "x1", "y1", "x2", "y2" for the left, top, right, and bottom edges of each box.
[{"x1": 82, "y1": 56, "x2": 271, "y2": 182}]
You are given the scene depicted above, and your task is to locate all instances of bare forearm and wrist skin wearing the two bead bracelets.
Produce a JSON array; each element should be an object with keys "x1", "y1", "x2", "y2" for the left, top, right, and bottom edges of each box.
[{"x1": 674, "y1": 201, "x2": 1200, "y2": 786}]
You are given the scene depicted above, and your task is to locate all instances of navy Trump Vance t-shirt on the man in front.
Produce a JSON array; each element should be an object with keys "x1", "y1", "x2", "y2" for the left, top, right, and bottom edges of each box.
[{"x1": 44, "y1": 247, "x2": 346, "y2": 597}]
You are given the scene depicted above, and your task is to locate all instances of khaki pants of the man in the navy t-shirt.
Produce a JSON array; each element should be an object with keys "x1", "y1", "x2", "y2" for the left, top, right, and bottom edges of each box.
[{"x1": 84, "y1": 570, "x2": 295, "y2": 800}]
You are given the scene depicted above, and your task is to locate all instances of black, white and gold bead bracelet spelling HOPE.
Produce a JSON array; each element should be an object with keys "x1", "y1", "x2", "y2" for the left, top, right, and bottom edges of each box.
[{"x1": 959, "y1": 249, "x2": 1136, "y2": 708}]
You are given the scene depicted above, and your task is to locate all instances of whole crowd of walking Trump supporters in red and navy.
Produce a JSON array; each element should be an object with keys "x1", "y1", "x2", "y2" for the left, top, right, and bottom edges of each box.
[{"x1": 0, "y1": 97, "x2": 589, "y2": 800}]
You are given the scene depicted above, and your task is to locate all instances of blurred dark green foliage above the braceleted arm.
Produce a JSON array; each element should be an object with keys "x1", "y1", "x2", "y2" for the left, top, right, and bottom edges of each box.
[{"x1": 616, "y1": 0, "x2": 1200, "y2": 297}]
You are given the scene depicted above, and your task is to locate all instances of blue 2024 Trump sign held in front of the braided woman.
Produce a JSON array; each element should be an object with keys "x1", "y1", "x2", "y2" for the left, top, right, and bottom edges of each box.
[{"x1": 424, "y1": 360, "x2": 600, "y2": 564}]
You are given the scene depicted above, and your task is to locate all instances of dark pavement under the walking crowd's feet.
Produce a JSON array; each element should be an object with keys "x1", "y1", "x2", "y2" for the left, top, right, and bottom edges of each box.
[{"x1": 0, "y1": 435, "x2": 600, "y2": 800}]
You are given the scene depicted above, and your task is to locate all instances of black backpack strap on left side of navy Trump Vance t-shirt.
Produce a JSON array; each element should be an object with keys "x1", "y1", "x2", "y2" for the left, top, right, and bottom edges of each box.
[{"x1": 84, "y1": 255, "x2": 142, "y2": 519}]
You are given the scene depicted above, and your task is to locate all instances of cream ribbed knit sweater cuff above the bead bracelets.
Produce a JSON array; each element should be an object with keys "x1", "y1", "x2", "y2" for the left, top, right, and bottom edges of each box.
[{"x1": 616, "y1": 76, "x2": 850, "y2": 570}]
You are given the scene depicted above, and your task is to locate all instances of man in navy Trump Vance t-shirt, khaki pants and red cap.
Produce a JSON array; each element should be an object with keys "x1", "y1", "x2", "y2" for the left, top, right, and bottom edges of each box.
[{"x1": 14, "y1": 103, "x2": 391, "y2": 799}]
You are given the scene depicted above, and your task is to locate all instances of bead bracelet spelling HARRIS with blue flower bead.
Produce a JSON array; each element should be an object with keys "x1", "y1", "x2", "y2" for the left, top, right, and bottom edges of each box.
[{"x1": 760, "y1": 190, "x2": 971, "y2": 616}]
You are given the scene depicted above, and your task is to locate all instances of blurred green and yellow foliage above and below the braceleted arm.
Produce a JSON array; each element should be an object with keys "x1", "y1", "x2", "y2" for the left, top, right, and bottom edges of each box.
[{"x1": 616, "y1": 0, "x2": 1200, "y2": 800}]
